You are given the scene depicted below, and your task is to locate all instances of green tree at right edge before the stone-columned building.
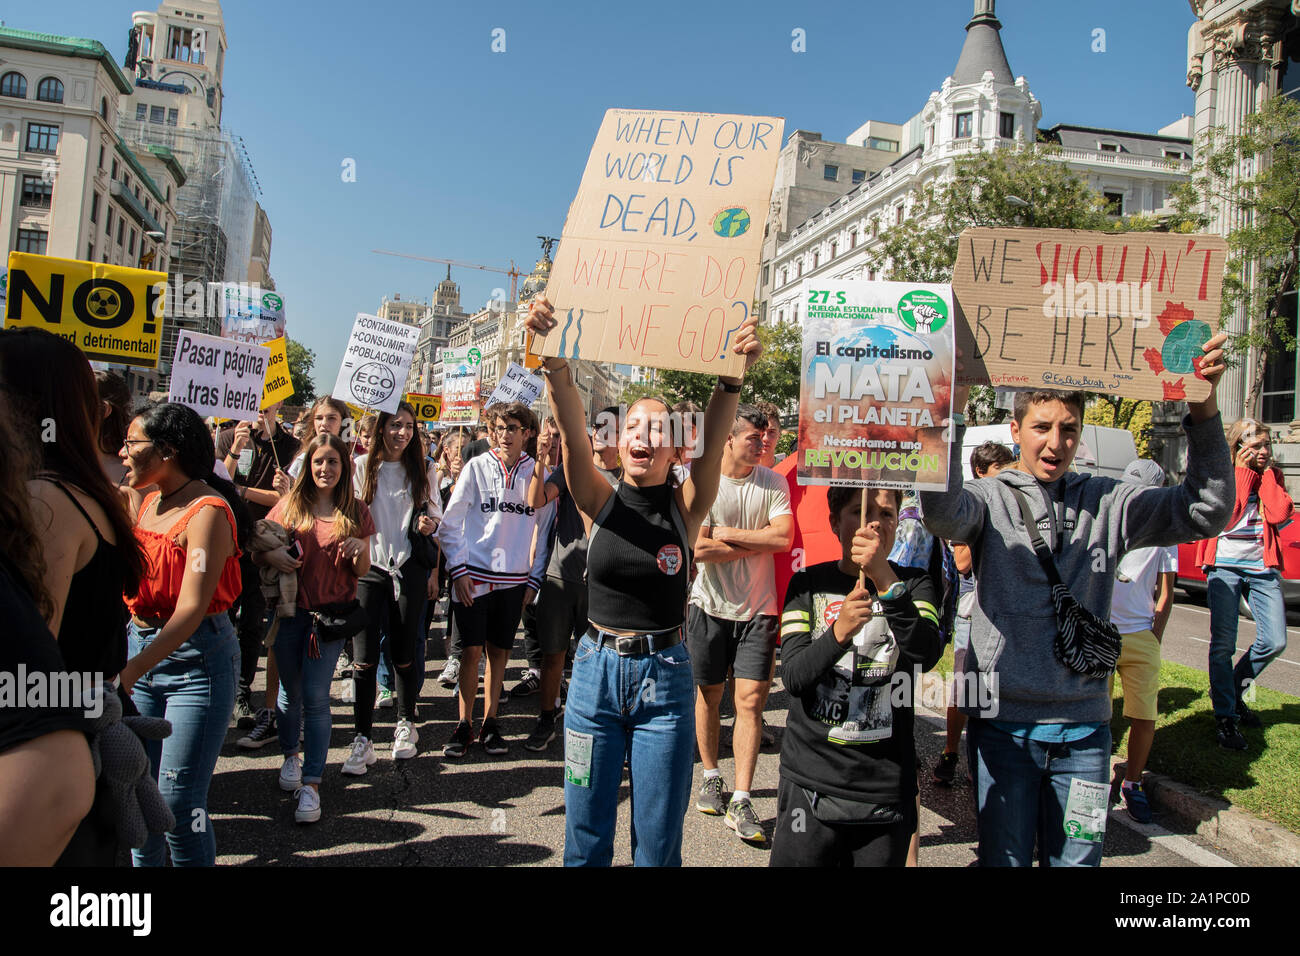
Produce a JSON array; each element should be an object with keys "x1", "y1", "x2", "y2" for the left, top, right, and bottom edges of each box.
[{"x1": 1178, "y1": 96, "x2": 1300, "y2": 415}]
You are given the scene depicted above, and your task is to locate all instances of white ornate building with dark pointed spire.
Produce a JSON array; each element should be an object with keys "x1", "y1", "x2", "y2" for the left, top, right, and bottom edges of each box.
[{"x1": 758, "y1": 0, "x2": 1192, "y2": 329}]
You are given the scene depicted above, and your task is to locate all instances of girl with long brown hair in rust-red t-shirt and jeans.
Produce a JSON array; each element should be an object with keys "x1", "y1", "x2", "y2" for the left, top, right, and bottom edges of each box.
[{"x1": 256, "y1": 432, "x2": 374, "y2": 823}]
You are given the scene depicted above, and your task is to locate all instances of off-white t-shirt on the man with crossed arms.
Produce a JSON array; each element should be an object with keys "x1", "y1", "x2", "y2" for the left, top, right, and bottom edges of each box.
[{"x1": 690, "y1": 466, "x2": 792, "y2": 620}]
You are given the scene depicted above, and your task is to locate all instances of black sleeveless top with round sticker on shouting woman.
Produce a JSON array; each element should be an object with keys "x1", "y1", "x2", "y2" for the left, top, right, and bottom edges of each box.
[{"x1": 586, "y1": 481, "x2": 690, "y2": 632}]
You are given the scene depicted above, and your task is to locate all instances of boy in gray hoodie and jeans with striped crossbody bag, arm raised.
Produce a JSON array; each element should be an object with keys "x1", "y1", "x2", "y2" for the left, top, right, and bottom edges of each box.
[{"x1": 920, "y1": 334, "x2": 1232, "y2": 866}]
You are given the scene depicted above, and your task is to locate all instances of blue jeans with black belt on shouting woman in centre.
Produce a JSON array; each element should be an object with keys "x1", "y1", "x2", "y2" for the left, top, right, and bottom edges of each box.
[{"x1": 564, "y1": 637, "x2": 696, "y2": 866}]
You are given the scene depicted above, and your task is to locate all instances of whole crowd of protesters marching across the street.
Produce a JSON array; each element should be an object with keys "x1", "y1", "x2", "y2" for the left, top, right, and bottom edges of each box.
[{"x1": 0, "y1": 310, "x2": 1292, "y2": 866}]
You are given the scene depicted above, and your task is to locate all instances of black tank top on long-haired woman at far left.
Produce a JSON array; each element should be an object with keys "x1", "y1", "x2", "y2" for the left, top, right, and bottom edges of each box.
[{"x1": 42, "y1": 479, "x2": 127, "y2": 678}]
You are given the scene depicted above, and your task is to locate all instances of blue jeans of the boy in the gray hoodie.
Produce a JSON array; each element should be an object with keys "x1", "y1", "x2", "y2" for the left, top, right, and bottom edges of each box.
[{"x1": 966, "y1": 717, "x2": 1110, "y2": 866}]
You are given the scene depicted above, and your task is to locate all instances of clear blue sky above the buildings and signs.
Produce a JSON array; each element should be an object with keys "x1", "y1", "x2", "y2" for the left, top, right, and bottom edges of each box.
[{"x1": 25, "y1": 0, "x2": 1195, "y2": 392}]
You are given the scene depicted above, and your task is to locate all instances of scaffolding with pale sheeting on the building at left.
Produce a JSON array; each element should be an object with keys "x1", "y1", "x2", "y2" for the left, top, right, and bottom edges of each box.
[{"x1": 118, "y1": 118, "x2": 261, "y2": 375}]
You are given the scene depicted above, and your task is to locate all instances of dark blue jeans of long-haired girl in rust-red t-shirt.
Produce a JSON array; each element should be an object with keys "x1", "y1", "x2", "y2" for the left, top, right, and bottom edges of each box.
[{"x1": 273, "y1": 609, "x2": 343, "y2": 783}]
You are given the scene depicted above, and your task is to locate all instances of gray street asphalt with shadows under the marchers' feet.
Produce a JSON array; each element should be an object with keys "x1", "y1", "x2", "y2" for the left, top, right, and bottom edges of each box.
[{"x1": 209, "y1": 594, "x2": 1274, "y2": 866}]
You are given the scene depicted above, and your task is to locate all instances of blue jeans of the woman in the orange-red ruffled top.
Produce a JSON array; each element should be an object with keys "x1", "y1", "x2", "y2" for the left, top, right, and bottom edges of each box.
[{"x1": 129, "y1": 614, "x2": 239, "y2": 866}]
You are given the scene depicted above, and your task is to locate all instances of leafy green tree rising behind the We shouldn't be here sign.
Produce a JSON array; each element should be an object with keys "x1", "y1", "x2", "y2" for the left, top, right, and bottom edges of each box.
[{"x1": 871, "y1": 143, "x2": 1200, "y2": 424}]
